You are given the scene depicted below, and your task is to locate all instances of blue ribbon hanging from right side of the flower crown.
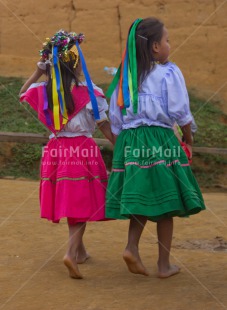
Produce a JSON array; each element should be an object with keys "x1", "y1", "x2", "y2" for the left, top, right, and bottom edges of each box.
[{"x1": 76, "y1": 41, "x2": 100, "y2": 120}]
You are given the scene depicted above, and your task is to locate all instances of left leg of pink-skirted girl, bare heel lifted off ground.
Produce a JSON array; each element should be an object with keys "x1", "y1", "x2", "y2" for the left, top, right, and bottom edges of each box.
[{"x1": 63, "y1": 222, "x2": 86, "y2": 279}]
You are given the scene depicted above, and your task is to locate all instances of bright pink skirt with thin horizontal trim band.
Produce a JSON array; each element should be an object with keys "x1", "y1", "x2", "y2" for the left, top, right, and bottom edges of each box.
[{"x1": 40, "y1": 136, "x2": 107, "y2": 223}]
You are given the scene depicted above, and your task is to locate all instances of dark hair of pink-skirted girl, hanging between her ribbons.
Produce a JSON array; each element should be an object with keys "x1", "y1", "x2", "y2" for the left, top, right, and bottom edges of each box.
[{"x1": 46, "y1": 54, "x2": 80, "y2": 115}]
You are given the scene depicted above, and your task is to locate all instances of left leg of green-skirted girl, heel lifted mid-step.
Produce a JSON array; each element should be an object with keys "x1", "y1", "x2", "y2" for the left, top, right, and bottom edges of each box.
[{"x1": 123, "y1": 215, "x2": 149, "y2": 276}]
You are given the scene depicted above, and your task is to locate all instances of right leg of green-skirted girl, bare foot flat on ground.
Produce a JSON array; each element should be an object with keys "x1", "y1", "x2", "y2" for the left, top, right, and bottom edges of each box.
[{"x1": 157, "y1": 218, "x2": 180, "y2": 278}]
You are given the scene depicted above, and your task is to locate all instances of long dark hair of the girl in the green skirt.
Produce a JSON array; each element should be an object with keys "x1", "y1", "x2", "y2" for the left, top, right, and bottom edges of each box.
[{"x1": 135, "y1": 17, "x2": 164, "y2": 85}]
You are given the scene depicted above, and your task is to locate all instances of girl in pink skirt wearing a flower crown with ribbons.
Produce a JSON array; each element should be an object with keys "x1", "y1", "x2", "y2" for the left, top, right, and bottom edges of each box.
[{"x1": 20, "y1": 30, "x2": 113, "y2": 279}]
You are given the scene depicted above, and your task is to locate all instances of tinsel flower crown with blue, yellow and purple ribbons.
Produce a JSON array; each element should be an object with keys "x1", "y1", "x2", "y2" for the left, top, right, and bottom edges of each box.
[{"x1": 40, "y1": 30, "x2": 100, "y2": 130}]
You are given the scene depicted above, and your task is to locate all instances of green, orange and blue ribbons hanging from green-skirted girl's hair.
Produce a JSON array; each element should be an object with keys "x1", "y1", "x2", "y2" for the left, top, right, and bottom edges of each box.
[{"x1": 106, "y1": 18, "x2": 142, "y2": 114}]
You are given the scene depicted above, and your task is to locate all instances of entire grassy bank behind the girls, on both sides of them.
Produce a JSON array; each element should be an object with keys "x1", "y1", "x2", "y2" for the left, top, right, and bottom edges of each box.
[{"x1": 0, "y1": 77, "x2": 227, "y2": 187}]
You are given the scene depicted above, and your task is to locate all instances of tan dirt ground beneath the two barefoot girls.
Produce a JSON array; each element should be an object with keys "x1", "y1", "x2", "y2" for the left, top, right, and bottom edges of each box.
[{"x1": 0, "y1": 179, "x2": 227, "y2": 310}]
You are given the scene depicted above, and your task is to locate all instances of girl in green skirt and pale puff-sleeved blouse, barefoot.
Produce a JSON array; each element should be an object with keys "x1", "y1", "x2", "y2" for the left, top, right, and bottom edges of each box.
[{"x1": 106, "y1": 18, "x2": 205, "y2": 278}]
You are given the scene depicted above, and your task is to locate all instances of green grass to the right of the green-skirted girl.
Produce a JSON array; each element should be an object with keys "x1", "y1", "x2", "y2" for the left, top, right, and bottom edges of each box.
[{"x1": 190, "y1": 92, "x2": 227, "y2": 189}]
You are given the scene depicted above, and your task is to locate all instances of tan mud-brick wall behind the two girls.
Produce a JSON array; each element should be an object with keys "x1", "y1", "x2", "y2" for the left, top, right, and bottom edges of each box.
[{"x1": 0, "y1": 0, "x2": 227, "y2": 105}]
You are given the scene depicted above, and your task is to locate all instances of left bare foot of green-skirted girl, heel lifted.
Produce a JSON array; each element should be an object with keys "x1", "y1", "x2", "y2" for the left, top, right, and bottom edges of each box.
[{"x1": 123, "y1": 250, "x2": 149, "y2": 276}]
